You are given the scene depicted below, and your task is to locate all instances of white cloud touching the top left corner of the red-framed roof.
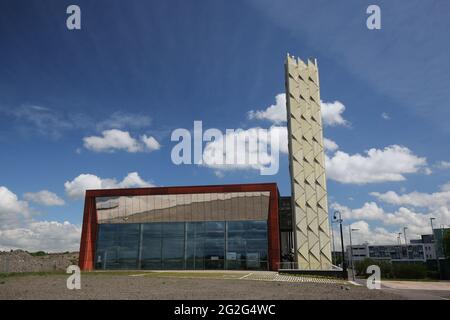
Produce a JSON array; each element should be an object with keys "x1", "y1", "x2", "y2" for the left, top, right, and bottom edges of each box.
[{"x1": 64, "y1": 172, "x2": 153, "y2": 199}]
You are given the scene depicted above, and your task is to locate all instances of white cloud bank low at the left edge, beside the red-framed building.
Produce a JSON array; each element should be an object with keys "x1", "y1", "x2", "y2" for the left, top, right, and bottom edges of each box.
[{"x1": 0, "y1": 186, "x2": 81, "y2": 251}]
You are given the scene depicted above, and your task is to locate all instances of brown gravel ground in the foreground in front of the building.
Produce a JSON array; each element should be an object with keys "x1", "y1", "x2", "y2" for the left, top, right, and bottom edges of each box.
[{"x1": 0, "y1": 274, "x2": 401, "y2": 300}]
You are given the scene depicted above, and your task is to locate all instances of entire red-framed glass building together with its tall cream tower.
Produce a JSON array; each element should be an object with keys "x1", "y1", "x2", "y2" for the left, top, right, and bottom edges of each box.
[{"x1": 79, "y1": 55, "x2": 333, "y2": 271}]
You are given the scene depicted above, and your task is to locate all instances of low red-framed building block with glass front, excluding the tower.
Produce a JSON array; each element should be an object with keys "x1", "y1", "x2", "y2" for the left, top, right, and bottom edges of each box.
[{"x1": 79, "y1": 183, "x2": 280, "y2": 270}]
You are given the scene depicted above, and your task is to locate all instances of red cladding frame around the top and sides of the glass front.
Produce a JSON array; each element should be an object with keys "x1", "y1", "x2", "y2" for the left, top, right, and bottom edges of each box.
[{"x1": 79, "y1": 183, "x2": 280, "y2": 271}]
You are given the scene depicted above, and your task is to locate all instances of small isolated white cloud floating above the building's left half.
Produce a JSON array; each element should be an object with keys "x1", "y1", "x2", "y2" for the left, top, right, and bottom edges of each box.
[{"x1": 83, "y1": 129, "x2": 160, "y2": 153}]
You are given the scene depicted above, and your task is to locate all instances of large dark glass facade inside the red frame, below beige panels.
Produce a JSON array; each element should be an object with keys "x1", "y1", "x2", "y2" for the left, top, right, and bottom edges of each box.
[{"x1": 95, "y1": 220, "x2": 268, "y2": 270}]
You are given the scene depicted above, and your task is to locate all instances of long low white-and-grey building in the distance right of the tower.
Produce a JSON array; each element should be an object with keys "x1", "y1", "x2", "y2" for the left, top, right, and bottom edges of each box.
[{"x1": 346, "y1": 243, "x2": 426, "y2": 263}]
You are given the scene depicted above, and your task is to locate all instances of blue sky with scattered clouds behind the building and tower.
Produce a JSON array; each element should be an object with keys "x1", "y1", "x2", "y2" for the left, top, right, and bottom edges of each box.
[{"x1": 0, "y1": 0, "x2": 450, "y2": 250}]
